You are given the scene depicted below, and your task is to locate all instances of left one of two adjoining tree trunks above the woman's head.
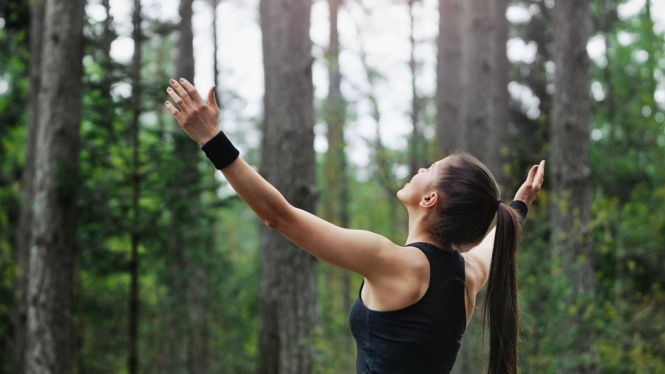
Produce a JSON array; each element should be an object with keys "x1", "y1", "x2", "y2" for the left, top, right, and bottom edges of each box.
[{"x1": 436, "y1": 0, "x2": 463, "y2": 155}]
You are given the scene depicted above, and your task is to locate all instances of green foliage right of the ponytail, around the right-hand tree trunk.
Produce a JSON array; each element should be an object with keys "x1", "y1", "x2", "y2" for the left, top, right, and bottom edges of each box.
[{"x1": 508, "y1": 1, "x2": 665, "y2": 373}]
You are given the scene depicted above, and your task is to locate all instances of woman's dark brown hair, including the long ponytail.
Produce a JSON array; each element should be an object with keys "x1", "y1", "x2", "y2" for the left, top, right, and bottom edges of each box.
[{"x1": 431, "y1": 153, "x2": 522, "y2": 374}]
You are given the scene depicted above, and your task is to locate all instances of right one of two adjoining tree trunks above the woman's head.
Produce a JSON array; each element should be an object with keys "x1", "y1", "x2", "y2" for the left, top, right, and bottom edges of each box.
[{"x1": 458, "y1": 0, "x2": 493, "y2": 162}]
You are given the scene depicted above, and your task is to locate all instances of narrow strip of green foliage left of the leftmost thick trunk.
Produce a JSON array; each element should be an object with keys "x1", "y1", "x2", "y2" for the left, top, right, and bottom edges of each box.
[{"x1": 0, "y1": 1, "x2": 28, "y2": 372}]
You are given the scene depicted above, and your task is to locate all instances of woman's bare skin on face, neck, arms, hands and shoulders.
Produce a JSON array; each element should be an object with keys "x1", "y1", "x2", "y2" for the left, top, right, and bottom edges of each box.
[{"x1": 165, "y1": 79, "x2": 545, "y2": 323}]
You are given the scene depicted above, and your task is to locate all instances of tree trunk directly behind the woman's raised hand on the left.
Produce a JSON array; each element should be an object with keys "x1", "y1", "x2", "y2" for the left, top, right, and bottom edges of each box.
[{"x1": 170, "y1": 0, "x2": 209, "y2": 374}]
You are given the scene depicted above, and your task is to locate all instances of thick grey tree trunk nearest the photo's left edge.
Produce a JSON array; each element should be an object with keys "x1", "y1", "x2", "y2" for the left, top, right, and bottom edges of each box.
[{"x1": 26, "y1": 0, "x2": 85, "y2": 374}]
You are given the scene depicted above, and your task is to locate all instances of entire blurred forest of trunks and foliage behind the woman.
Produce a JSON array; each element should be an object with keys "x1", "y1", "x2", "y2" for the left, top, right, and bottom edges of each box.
[{"x1": 0, "y1": 0, "x2": 665, "y2": 374}]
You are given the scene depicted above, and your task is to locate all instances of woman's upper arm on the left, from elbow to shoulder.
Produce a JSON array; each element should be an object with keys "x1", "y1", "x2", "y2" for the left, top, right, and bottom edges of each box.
[{"x1": 271, "y1": 207, "x2": 408, "y2": 279}]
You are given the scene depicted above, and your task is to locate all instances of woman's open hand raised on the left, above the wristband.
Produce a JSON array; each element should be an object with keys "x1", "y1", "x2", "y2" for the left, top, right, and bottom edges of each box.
[{"x1": 165, "y1": 78, "x2": 219, "y2": 145}]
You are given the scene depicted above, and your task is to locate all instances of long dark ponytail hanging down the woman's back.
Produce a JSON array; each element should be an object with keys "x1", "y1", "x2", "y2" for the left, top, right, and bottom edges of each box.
[{"x1": 484, "y1": 204, "x2": 522, "y2": 374}]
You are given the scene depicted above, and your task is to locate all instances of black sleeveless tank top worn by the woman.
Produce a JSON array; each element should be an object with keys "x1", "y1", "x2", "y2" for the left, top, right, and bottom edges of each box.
[{"x1": 349, "y1": 243, "x2": 466, "y2": 374}]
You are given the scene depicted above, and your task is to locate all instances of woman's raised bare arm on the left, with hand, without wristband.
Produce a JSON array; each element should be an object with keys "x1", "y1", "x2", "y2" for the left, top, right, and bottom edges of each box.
[{"x1": 165, "y1": 79, "x2": 420, "y2": 280}]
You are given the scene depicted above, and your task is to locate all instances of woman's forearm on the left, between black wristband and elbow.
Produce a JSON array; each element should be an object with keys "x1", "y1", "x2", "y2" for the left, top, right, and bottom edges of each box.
[{"x1": 222, "y1": 157, "x2": 291, "y2": 227}]
